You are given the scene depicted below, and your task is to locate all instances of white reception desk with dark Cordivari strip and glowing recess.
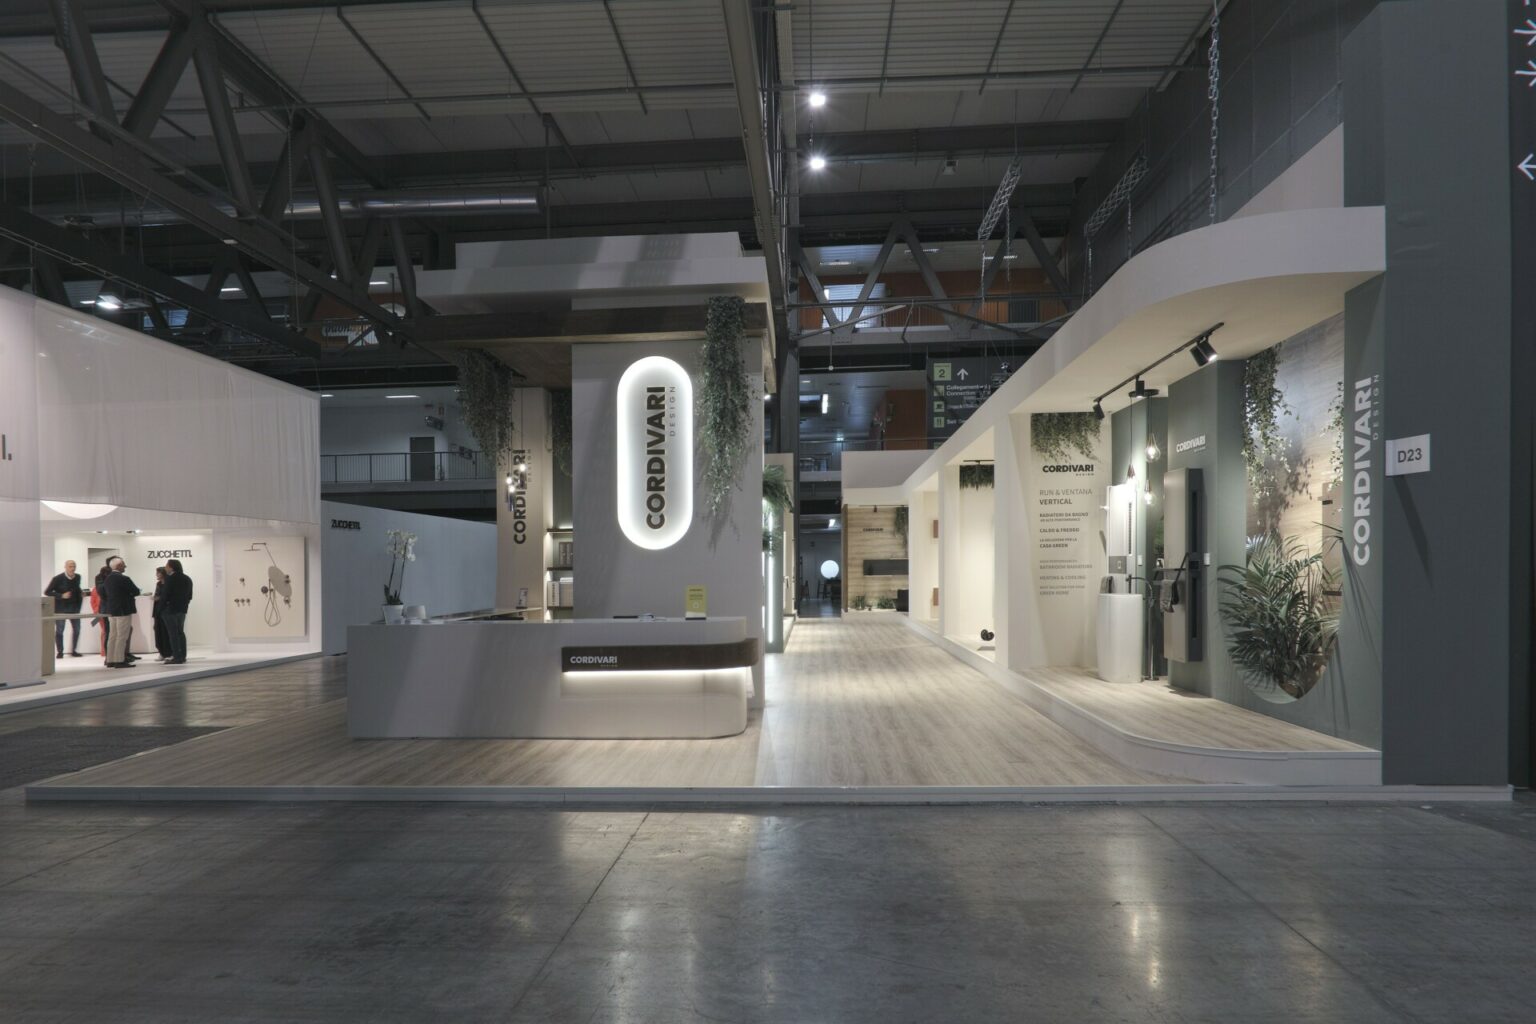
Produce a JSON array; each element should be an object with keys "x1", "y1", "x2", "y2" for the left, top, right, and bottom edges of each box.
[{"x1": 347, "y1": 617, "x2": 760, "y2": 738}]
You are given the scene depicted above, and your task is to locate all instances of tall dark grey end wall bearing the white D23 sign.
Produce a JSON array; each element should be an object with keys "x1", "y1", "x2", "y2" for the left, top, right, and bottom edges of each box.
[{"x1": 1346, "y1": 0, "x2": 1511, "y2": 785}]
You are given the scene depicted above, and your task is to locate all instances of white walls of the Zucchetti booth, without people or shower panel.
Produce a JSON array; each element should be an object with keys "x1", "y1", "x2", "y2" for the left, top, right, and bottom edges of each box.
[{"x1": 0, "y1": 289, "x2": 319, "y2": 683}]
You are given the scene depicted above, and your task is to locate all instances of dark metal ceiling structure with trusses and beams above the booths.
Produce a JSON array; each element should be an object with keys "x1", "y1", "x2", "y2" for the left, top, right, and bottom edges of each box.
[{"x1": 0, "y1": 0, "x2": 1210, "y2": 384}]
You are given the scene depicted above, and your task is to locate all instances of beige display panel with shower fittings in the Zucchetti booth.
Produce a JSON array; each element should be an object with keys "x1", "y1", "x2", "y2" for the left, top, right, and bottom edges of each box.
[{"x1": 224, "y1": 537, "x2": 309, "y2": 640}]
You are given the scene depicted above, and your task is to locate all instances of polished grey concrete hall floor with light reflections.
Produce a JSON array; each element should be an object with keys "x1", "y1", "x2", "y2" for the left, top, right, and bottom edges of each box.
[{"x1": 0, "y1": 660, "x2": 1536, "y2": 1024}]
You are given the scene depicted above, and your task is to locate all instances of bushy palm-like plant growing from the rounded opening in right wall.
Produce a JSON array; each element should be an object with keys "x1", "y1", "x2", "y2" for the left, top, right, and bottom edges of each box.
[{"x1": 1217, "y1": 533, "x2": 1339, "y2": 703}]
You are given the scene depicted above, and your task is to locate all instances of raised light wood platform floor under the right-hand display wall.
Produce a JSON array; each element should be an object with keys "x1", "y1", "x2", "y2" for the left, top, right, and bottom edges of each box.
[{"x1": 1020, "y1": 668, "x2": 1370, "y2": 751}]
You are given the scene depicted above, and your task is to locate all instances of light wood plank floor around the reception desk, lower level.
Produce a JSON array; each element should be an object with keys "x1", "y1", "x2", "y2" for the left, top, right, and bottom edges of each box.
[{"x1": 38, "y1": 619, "x2": 1180, "y2": 789}]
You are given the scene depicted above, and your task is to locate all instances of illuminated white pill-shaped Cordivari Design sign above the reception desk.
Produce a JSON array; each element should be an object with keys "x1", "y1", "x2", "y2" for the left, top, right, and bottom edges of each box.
[{"x1": 616, "y1": 356, "x2": 693, "y2": 551}]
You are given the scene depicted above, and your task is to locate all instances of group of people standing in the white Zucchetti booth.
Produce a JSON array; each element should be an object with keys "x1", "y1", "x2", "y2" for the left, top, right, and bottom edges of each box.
[{"x1": 43, "y1": 556, "x2": 192, "y2": 668}]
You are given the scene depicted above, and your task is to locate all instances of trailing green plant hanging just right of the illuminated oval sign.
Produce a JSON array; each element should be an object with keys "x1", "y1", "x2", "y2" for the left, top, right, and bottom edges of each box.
[{"x1": 696, "y1": 295, "x2": 753, "y2": 517}]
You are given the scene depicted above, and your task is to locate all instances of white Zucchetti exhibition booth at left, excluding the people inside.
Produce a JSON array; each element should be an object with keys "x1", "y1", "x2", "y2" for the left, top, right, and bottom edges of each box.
[{"x1": 0, "y1": 290, "x2": 321, "y2": 709}]
